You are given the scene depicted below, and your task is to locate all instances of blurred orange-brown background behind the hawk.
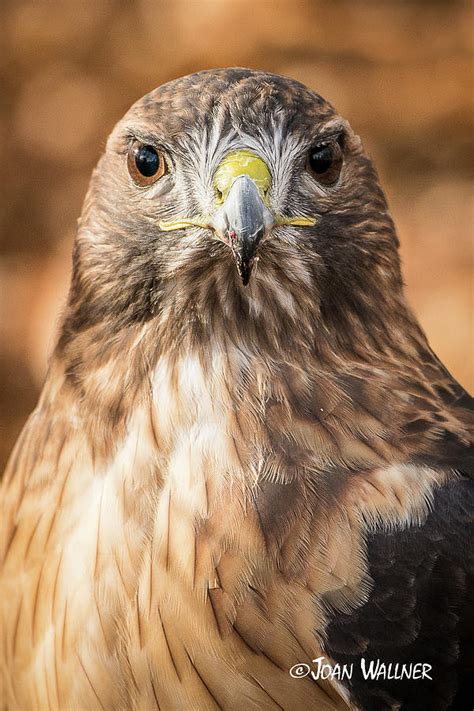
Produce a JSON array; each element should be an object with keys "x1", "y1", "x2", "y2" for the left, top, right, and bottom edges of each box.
[{"x1": 0, "y1": 0, "x2": 474, "y2": 471}]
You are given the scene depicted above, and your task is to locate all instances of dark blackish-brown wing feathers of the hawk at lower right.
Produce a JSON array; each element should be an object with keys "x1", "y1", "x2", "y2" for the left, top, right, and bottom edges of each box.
[{"x1": 326, "y1": 477, "x2": 474, "y2": 709}]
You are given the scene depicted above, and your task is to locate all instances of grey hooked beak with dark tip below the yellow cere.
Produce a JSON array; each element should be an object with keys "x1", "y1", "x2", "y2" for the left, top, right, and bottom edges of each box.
[{"x1": 210, "y1": 175, "x2": 275, "y2": 286}]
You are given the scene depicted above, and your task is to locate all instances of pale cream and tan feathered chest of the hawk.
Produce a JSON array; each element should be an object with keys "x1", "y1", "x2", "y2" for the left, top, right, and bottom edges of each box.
[{"x1": 2, "y1": 350, "x2": 448, "y2": 709}]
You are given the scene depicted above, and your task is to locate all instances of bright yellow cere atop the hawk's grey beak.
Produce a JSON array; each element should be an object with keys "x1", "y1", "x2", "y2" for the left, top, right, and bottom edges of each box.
[{"x1": 214, "y1": 150, "x2": 272, "y2": 206}]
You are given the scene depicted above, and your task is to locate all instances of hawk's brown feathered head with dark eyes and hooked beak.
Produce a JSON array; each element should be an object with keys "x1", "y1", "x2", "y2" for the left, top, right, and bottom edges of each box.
[{"x1": 69, "y1": 69, "x2": 400, "y2": 356}]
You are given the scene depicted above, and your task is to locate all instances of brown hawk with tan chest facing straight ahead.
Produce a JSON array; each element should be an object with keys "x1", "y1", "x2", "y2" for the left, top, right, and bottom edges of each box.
[{"x1": 0, "y1": 69, "x2": 474, "y2": 711}]
